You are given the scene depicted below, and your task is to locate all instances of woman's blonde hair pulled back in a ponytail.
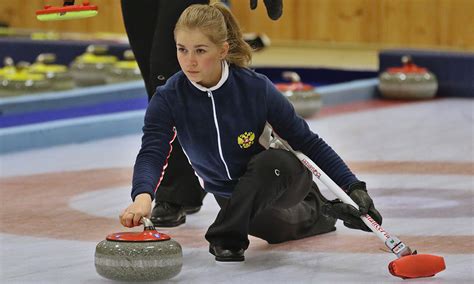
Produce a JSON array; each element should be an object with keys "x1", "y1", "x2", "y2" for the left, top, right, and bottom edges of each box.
[{"x1": 174, "y1": 2, "x2": 252, "y2": 67}]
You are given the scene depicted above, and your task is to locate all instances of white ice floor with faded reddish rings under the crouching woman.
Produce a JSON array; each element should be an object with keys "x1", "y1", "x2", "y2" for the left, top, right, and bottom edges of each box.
[{"x1": 0, "y1": 99, "x2": 474, "y2": 283}]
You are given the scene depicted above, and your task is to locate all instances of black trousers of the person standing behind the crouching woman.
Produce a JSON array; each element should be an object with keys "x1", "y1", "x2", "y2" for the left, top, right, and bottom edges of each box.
[{"x1": 121, "y1": 0, "x2": 209, "y2": 206}]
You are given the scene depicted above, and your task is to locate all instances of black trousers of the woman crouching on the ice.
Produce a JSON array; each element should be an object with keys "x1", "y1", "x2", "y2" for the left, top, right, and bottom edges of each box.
[{"x1": 206, "y1": 149, "x2": 336, "y2": 249}]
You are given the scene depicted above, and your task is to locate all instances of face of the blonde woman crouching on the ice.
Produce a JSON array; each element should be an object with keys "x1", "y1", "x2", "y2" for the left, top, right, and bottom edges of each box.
[{"x1": 175, "y1": 29, "x2": 229, "y2": 88}]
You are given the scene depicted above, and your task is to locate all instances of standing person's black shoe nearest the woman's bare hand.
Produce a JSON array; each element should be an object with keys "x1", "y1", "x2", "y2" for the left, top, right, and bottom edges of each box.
[{"x1": 150, "y1": 201, "x2": 186, "y2": 227}]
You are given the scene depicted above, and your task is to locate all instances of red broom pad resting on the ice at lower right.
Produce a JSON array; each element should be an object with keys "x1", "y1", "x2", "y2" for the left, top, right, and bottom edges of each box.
[{"x1": 388, "y1": 254, "x2": 446, "y2": 279}]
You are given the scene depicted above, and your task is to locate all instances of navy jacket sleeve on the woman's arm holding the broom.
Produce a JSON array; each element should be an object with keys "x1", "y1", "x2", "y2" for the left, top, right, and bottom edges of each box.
[{"x1": 266, "y1": 79, "x2": 358, "y2": 190}]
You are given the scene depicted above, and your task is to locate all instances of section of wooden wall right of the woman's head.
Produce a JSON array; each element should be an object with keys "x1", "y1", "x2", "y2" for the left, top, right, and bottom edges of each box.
[{"x1": 234, "y1": 0, "x2": 474, "y2": 48}]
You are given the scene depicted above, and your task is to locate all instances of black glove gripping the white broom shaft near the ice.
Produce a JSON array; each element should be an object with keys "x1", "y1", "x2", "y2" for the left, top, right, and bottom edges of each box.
[{"x1": 321, "y1": 182, "x2": 382, "y2": 232}]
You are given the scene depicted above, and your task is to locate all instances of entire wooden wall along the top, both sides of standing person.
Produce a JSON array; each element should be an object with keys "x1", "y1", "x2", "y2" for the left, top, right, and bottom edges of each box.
[{"x1": 0, "y1": 0, "x2": 474, "y2": 49}]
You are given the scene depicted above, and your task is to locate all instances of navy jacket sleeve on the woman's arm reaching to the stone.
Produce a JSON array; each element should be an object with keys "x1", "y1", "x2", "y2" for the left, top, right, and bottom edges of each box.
[{"x1": 132, "y1": 89, "x2": 176, "y2": 200}]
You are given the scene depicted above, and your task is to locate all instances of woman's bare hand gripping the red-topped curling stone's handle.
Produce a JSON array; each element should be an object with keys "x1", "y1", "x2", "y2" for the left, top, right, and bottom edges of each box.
[{"x1": 119, "y1": 193, "x2": 151, "y2": 228}]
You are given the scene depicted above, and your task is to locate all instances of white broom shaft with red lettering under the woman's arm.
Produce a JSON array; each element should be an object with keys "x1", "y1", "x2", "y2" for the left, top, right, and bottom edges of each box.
[{"x1": 290, "y1": 151, "x2": 390, "y2": 242}]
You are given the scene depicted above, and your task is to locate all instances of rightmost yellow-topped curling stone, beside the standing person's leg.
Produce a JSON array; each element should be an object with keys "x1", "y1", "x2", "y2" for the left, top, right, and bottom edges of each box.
[{"x1": 107, "y1": 49, "x2": 142, "y2": 83}]
